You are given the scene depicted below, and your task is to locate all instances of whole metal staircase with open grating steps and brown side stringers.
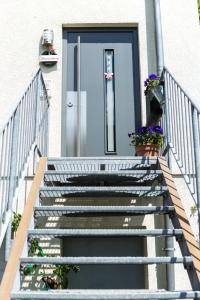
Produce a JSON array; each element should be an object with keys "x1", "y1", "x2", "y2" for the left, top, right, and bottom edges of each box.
[{"x1": 0, "y1": 157, "x2": 200, "y2": 300}]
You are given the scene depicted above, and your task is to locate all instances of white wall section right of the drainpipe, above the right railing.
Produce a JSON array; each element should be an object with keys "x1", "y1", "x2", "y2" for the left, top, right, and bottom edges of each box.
[{"x1": 160, "y1": 0, "x2": 200, "y2": 109}]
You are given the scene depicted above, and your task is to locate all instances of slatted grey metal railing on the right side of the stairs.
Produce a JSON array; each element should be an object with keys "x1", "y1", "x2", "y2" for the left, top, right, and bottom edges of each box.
[{"x1": 162, "y1": 68, "x2": 200, "y2": 238}]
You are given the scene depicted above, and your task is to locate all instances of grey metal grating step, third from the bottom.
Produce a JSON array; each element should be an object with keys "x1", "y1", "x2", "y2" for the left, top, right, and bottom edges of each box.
[{"x1": 28, "y1": 229, "x2": 183, "y2": 238}]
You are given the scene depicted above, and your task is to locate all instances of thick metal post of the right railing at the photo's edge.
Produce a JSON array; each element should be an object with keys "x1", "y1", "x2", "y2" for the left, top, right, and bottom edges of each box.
[{"x1": 192, "y1": 108, "x2": 200, "y2": 244}]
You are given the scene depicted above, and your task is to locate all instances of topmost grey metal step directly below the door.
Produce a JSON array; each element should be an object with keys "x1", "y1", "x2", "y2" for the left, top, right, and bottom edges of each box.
[{"x1": 47, "y1": 156, "x2": 158, "y2": 171}]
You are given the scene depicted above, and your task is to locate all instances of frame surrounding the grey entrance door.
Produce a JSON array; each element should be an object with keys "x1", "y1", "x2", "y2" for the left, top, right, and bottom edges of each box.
[{"x1": 61, "y1": 27, "x2": 142, "y2": 156}]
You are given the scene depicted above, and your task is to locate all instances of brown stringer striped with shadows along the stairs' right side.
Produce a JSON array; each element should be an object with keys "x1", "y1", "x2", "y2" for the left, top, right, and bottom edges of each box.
[{"x1": 158, "y1": 157, "x2": 200, "y2": 282}]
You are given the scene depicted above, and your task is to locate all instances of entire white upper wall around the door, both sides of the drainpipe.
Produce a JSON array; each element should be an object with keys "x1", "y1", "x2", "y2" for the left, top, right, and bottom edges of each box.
[{"x1": 0, "y1": 0, "x2": 200, "y2": 152}]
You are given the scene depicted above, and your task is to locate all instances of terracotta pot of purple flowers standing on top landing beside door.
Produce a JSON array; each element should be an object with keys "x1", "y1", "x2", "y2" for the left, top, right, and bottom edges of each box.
[{"x1": 128, "y1": 126, "x2": 164, "y2": 156}]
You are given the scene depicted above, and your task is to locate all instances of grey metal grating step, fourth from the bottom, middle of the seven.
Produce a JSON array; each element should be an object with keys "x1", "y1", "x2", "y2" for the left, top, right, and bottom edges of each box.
[{"x1": 34, "y1": 206, "x2": 175, "y2": 217}]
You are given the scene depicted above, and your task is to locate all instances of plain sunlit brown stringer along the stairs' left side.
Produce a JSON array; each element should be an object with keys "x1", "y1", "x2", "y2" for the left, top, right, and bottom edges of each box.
[{"x1": 0, "y1": 157, "x2": 47, "y2": 300}]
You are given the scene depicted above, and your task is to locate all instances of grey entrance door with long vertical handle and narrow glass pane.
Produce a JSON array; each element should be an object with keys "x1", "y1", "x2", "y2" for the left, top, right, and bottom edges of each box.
[{"x1": 63, "y1": 30, "x2": 140, "y2": 156}]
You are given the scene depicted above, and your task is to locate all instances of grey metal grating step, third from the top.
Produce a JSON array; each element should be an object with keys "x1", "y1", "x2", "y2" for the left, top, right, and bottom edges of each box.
[{"x1": 40, "y1": 186, "x2": 168, "y2": 198}]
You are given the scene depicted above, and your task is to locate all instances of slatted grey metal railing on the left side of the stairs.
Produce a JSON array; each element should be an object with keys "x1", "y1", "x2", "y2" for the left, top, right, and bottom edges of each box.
[{"x1": 0, "y1": 69, "x2": 49, "y2": 250}]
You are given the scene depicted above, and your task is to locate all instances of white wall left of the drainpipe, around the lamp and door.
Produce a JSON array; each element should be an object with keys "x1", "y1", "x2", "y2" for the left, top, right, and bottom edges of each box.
[{"x1": 0, "y1": 0, "x2": 147, "y2": 156}]
